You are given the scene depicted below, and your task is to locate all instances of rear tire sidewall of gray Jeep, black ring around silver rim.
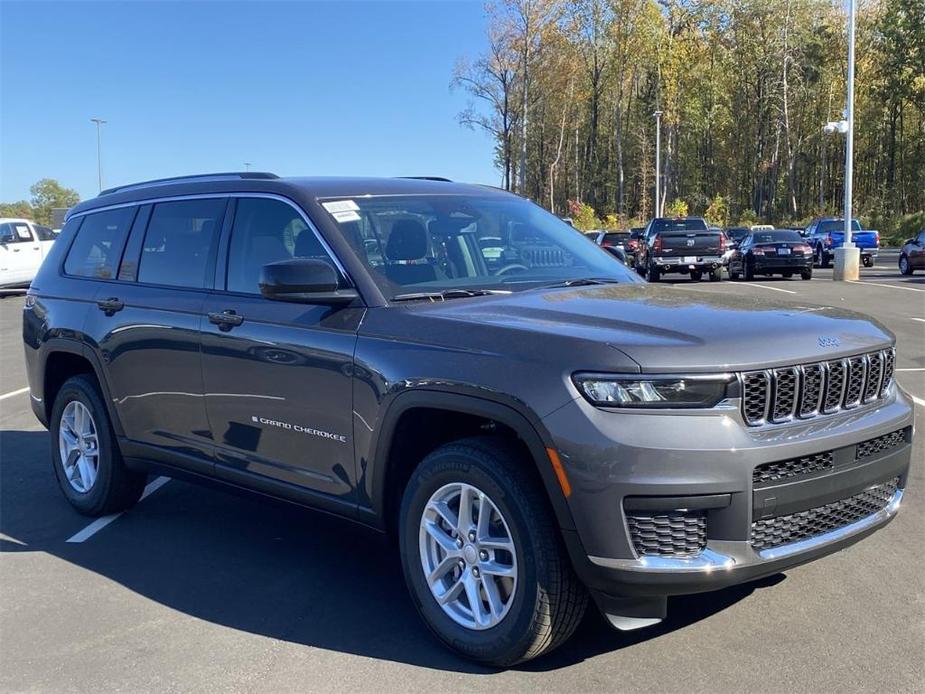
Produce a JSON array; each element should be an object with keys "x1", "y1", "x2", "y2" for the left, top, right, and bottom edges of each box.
[{"x1": 49, "y1": 377, "x2": 115, "y2": 515}]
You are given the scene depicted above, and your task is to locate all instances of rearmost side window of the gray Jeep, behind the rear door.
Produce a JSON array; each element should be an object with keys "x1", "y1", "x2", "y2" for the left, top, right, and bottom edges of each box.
[{"x1": 64, "y1": 207, "x2": 137, "y2": 279}]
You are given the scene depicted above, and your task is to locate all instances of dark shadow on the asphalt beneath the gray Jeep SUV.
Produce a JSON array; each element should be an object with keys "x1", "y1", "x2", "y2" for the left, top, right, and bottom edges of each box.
[{"x1": 0, "y1": 431, "x2": 783, "y2": 673}]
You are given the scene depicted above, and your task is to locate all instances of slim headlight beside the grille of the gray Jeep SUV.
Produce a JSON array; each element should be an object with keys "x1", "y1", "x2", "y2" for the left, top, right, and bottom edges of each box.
[{"x1": 572, "y1": 374, "x2": 735, "y2": 409}]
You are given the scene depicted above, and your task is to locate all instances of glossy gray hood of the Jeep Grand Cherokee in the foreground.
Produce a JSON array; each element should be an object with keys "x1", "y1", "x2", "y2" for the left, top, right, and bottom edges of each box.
[{"x1": 408, "y1": 283, "x2": 893, "y2": 372}]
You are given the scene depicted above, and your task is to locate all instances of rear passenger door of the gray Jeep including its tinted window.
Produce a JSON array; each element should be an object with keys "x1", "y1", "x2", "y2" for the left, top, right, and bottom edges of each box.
[{"x1": 81, "y1": 197, "x2": 228, "y2": 473}]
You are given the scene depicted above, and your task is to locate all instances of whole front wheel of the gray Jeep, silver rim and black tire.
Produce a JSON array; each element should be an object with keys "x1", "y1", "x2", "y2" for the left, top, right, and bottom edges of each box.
[{"x1": 399, "y1": 437, "x2": 587, "y2": 666}]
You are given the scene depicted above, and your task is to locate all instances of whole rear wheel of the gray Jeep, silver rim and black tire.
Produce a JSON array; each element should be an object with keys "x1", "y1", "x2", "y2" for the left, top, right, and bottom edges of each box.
[{"x1": 50, "y1": 375, "x2": 146, "y2": 516}]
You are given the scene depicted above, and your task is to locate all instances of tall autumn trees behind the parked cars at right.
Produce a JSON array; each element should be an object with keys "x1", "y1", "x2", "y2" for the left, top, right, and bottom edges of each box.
[{"x1": 452, "y1": 0, "x2": 925, "y2": 237}]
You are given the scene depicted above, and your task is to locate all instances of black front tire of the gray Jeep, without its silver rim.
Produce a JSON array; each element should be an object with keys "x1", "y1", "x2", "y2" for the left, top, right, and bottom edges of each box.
[{"x1": 399, "y1": 437, "x2": 588, "y2": 667}]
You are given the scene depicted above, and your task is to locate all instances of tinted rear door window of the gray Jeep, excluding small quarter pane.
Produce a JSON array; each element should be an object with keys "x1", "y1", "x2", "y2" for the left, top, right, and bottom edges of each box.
[{"x1": 138, "y1": 198, "x2": 226, "y2": 289}]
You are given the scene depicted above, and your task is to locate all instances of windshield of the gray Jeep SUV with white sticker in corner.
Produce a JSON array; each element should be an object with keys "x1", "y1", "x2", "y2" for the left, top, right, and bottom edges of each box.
[{"x1": 321, "y1": 195, "x2": 640, "y2": 299}]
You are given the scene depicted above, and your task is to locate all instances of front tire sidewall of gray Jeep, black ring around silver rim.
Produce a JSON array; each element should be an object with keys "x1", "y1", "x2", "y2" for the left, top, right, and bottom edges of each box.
[{"x1": 399, "y1": 452, "x2": 542, "y2": 662}]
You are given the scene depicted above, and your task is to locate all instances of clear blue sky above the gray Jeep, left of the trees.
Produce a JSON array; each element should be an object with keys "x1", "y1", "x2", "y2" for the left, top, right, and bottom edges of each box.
[{"x1": 0, "y1": 0, "x2": 499, "y2": 202}]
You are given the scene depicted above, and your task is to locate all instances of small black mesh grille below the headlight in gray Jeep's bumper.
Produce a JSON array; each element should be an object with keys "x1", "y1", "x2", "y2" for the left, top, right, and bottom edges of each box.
[{"x1": 626, "y1": 511, "x2": 707, "y2": 557}]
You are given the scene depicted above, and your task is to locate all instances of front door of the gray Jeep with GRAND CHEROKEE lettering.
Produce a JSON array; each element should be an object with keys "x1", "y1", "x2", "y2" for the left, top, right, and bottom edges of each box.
[{"x1": 202, "y1": 197, "x2": 363, "y2": 507}]
